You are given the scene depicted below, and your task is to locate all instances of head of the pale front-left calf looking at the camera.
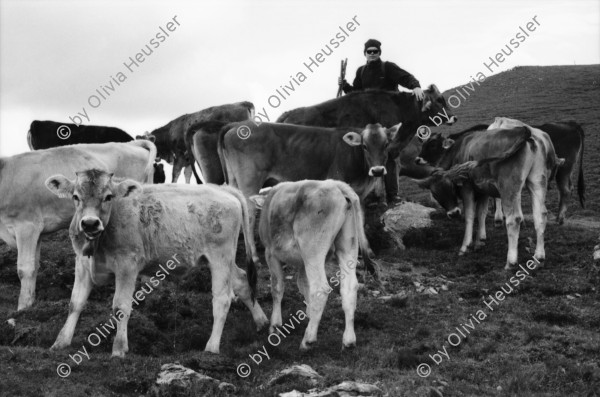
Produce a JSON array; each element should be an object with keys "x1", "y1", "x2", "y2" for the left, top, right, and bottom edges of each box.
[{"x1": 46, "y1": 169, "x2": 142, "y2": 241}]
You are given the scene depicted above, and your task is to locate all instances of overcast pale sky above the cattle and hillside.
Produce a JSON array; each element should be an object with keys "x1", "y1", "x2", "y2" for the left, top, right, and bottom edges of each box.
[{"x1": 0, "y1": 0, "x2": 600, "y2": 156}]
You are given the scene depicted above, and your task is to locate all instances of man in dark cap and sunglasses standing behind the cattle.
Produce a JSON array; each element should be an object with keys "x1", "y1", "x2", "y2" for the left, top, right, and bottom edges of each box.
[{"x1": 338, "y1": 39, "x2": 423, "y2": 203}]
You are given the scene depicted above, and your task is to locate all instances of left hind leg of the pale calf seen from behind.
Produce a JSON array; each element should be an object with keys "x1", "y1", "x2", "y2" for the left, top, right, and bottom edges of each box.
[{"x1": 300, "y1": 254, "x2": 331, "y2": 350}]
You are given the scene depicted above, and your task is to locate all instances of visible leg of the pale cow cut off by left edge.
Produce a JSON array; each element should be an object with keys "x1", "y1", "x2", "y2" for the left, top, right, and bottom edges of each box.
[{"x1": 15, "y1": 223, "x2": 42, "y2": 310}]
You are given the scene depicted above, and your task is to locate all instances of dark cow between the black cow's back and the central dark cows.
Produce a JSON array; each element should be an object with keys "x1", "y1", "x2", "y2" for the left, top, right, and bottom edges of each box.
[{"x1": 136, "y1": 101, "x2": 254, "y2": 184}]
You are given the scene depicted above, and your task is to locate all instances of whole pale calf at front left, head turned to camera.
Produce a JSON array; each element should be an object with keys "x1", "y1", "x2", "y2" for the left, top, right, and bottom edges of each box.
[{"x1": 46, "y1": 169, "x2": 268, "y2": 357}]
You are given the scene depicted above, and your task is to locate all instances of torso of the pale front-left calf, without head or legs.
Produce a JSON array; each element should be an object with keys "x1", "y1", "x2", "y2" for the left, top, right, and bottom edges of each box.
[{"x1": 100, "y1": 184, "x2": 242, "y2": 265}]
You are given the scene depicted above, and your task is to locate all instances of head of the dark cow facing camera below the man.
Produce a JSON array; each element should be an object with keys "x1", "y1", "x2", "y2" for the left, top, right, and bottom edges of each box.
[{"x1": 343, "y1": 123, "x2": 402, "y2": 177}]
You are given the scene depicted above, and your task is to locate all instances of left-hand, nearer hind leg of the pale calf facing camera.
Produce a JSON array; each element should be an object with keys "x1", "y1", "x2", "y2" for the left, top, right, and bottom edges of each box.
[{"x1": 204, "y1": 254, "x2": 235, "y2": 354}]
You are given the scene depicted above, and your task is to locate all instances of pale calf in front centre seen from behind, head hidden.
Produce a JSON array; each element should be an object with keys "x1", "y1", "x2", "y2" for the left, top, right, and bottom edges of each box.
[{"x1": 259, "y1": 180, "x2": 369, "y2": 350}]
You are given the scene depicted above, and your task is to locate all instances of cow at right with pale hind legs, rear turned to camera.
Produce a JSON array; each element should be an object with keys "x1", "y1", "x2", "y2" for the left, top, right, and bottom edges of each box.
[{"x1": 420, "y1": 122, "x2": 564, "y2": 269}]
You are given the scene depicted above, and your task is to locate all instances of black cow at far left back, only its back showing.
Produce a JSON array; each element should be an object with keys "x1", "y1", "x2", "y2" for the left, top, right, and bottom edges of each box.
[{"x1": 27, "y1": 120, "x2": 133, "y2": 150}]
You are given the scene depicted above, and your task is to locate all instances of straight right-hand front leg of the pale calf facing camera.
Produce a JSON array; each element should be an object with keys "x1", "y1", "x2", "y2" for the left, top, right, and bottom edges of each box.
[{"x1": 112, "y1": 266, "x2": 138, "y2": 358}]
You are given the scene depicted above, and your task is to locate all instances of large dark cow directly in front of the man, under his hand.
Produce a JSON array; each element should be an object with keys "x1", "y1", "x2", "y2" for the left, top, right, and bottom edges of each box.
[{"x1": 277, "y1": 84, "x2": 458, "y2": 203}]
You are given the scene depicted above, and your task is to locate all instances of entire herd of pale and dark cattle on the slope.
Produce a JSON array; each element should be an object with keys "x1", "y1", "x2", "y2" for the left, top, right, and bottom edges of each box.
[{"x1": 0, "y1": 85, "x2": 585, "y2": 357}]
